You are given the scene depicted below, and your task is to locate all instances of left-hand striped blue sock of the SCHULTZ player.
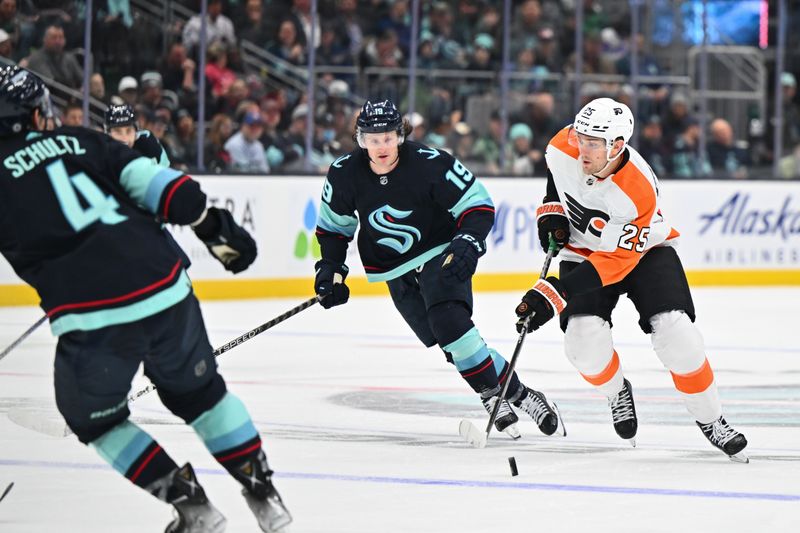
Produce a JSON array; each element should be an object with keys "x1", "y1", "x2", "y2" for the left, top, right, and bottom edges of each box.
[{"x1": 89, "y1": 420, "x2": 178, "y2": 490}]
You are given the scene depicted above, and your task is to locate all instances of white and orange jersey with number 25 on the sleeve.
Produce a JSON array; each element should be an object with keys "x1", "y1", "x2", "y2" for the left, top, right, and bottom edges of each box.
[{"x1": 545, "y1": 127, "x2": 679, "y2": 286}]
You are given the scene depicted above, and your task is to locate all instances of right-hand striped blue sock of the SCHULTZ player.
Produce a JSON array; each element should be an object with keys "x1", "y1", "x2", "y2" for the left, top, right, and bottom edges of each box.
[{"x1": 191, "y1": 392, "x2": 261, "y2": 481}]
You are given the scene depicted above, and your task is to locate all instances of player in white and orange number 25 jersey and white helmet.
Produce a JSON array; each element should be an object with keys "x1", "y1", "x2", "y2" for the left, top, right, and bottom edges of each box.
[{"x1": 516, "y1": 98, "x2": 747, "y2": 462}]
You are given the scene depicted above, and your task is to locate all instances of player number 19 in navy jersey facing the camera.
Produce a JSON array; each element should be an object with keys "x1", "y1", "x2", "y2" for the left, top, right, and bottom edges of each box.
[{"x1": 314, "y1": 100, "x2": 558, "y2": 438}]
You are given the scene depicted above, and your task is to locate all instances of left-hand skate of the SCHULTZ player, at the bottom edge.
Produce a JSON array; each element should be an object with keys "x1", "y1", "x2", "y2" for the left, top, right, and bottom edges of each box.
[{"x1": 164, "y1": 463, "x2": 226, "y2": 533}]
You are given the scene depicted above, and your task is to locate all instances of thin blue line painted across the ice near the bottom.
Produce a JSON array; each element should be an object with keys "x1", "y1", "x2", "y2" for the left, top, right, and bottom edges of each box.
[{"x1": 0, "y1": 459, "x2": 800, "y2": 502}]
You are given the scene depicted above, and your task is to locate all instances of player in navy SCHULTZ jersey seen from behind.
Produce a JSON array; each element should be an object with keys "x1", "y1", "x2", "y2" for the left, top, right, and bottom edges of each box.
[{"x1": 0, "y1": 67, "x2": 291, "y2": 533}]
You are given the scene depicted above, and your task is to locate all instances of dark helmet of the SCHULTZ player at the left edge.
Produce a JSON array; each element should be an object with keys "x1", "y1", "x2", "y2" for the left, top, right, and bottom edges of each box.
[{"x1": 0, "y1": 65, "x2": 53, "y2": 135}]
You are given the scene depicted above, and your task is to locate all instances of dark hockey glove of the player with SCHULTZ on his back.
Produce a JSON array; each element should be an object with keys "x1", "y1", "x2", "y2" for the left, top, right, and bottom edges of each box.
[{"x1": 193, "y1": 207, "x2": 258, "y2": 274}]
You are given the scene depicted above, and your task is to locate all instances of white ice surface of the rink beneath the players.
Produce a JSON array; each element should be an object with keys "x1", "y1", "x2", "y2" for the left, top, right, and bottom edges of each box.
[{"x1": 0, "y1": 288, "x2": 800, "y2": 533}]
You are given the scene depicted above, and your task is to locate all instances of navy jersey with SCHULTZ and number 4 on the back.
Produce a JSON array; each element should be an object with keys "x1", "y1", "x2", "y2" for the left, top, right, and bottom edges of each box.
[{"x1": 0, "y1": 127, "x2": 206, "y2": 335}]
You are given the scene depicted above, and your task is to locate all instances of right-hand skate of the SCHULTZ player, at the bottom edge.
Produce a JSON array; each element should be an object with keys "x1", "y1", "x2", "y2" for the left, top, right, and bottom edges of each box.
[{"x1": 233, "y1": 450, "x2": 292, "y2": 533}]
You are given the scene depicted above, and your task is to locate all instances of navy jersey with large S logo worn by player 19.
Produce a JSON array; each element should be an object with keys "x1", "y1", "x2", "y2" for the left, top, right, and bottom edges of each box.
[{"x1": 317, "y1": 141, "x2": 494, "y2": 281}]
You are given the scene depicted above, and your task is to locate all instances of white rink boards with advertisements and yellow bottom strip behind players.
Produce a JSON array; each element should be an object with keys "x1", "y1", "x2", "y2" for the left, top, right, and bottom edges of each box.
[{"x1": 0, "y1": 176, "x2": 800, "y2": 305}]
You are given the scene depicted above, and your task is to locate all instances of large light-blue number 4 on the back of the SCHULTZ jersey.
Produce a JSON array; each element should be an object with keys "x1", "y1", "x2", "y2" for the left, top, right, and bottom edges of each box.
[{"x1": 47, "y1": 160, "x2": 128, "y2": 231}]
